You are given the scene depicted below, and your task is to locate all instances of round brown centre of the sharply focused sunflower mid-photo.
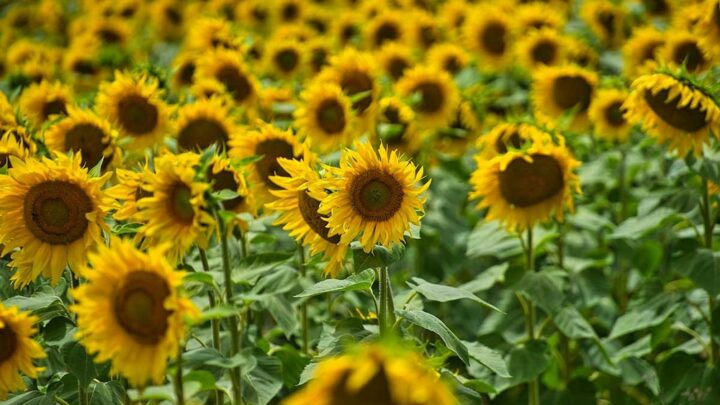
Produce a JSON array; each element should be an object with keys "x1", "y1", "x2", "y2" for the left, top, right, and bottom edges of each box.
[{"x1": 350, "y1": 169, "x2": 404, "y2": 222}]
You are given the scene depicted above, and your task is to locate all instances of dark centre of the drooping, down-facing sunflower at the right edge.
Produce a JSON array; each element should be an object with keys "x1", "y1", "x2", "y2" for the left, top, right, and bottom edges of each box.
[{"x1": 645, "y1": 89, "x2": 707, "y2": 132}]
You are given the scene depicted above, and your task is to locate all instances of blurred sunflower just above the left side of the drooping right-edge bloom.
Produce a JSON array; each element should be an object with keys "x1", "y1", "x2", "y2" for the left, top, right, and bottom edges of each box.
[{"x1": 622, "y1": 26, "x2": 665, "y2": 79}]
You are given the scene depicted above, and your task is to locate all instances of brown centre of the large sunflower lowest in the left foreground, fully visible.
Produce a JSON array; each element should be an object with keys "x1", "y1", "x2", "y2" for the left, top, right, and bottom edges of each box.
[{"x1": 113, "y1": 270, "x2": 172, "y2": 345}]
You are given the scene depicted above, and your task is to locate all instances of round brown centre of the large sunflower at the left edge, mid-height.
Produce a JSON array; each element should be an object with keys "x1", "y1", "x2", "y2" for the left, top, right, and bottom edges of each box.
[{"x1": 23, "y1": 180, "x2": 93, "y2": 245}]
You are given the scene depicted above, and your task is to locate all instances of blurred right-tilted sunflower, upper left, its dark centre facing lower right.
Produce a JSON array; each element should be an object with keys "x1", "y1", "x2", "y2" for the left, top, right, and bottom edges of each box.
[{"x1": 196, "y1": 49, "x2": 259, "y2": 108}]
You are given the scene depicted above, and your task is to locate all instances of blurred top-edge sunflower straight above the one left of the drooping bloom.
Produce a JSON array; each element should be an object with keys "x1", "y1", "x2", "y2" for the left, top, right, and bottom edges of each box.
[{"x1": 580, "y1": 0, "x2": 626, "y2": 47}]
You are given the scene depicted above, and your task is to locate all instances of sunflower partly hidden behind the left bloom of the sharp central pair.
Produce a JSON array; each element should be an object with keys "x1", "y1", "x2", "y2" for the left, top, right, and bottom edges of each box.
[{"x1": 229, "y1": 122, "x2": 311, "y2": 203}]
